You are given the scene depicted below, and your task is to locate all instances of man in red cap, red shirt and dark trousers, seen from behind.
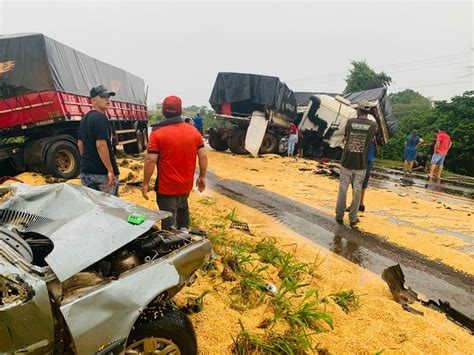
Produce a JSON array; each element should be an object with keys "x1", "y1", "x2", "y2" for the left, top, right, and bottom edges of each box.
[{"x1": 142, "y1": 96, "x2": 207, "y2": 230}]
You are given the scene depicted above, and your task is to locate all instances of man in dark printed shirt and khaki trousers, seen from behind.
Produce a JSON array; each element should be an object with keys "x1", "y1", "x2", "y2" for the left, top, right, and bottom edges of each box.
[{"x1": 336, "y1": 100, "x2": 377, "y2": 227}]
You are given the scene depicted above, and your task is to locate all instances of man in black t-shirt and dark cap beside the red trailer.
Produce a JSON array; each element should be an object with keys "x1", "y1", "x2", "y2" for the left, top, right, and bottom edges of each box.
[{"x1": 77, "y1": 85, "x2": 119, "y2": 196}]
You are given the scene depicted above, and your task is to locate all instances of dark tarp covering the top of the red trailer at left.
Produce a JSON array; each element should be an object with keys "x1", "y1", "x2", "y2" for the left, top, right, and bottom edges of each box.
[{"x1": 0, "y1": 33, "x2": 146, "y2": 105}]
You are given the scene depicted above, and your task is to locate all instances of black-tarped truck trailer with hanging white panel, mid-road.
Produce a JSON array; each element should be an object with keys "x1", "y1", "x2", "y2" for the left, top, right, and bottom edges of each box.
[{"x1": 208, "y1": 72, "x2": 296, "y2": 156}]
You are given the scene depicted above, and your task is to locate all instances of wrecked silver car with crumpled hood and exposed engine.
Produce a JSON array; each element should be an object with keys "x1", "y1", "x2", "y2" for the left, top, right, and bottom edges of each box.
[{"x1": 0, "y1": 183, "x2": 211, "y2": 354}]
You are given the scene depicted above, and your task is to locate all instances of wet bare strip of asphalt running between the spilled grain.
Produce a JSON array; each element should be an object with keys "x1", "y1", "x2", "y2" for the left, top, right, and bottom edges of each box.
[{"x1": 208, "y1": 173, "x2": 474, "y2": 318}]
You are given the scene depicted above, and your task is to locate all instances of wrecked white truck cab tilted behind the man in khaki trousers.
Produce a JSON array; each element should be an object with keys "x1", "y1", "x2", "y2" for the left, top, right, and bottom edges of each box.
[{"x1": 297, "y1": 88, "x2": 396, "y2": 159}]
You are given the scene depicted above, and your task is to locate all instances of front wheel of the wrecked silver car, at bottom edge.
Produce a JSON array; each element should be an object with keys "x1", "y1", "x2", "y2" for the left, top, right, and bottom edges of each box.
[{"x1": 125, "y1": 308, "x2": 197, "y2": 355}]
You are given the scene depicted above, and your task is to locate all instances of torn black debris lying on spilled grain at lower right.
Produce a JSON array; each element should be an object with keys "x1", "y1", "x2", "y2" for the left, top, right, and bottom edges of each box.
[{"x1": 382, "y1": 264, "x2": 474, "y2": 333}]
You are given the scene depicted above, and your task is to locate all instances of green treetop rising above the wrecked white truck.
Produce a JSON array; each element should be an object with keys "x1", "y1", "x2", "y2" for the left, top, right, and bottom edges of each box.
[{"x1": 344, "y1": 60, "x2": 392, "y2": 94}]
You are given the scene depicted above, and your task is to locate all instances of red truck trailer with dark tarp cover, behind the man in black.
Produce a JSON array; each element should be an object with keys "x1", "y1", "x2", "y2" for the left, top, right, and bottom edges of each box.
[{"x1": 0, "y1": 33, "x2": 148, "y2": 179}]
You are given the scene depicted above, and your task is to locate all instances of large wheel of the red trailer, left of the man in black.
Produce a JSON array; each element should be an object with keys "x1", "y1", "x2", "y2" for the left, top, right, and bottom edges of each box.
[{"x1": 45, "y1": 141, "x2": 81, "y2": 179}]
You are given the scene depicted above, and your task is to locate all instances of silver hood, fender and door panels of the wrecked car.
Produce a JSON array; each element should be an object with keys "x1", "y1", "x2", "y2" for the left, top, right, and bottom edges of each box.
[{"x1": 0, "y1": 184, "x2": 211, "y2": 354}]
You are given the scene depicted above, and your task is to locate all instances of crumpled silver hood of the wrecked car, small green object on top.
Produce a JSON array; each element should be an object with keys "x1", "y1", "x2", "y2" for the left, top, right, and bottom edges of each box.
[{"x1": 0, "y1": 183, "x2": 170, "y2": 282}]
